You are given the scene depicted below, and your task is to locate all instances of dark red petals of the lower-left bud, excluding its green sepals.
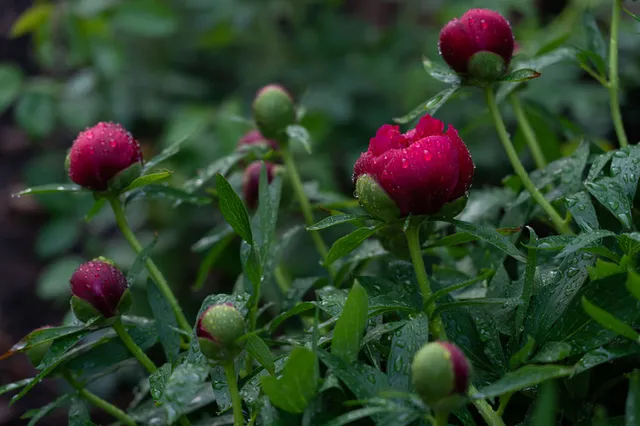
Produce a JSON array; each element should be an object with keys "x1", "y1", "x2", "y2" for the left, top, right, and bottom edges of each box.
[{"x1": 70, "y1": 260, "x2": 128, "y2": 320}]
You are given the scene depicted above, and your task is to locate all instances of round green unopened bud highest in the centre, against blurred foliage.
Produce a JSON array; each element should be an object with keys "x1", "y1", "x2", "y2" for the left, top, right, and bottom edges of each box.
[{"x1": 253, "y1": 84, "x2": 296, "y2": 140}]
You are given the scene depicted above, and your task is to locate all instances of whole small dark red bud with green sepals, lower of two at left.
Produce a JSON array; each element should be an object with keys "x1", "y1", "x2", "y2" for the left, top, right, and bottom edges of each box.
[{"x1": 70, "y1": 259, "x2": 131, "y2": 321}]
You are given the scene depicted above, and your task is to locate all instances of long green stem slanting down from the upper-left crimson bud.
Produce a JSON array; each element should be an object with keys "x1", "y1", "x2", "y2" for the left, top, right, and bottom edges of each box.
[{"x1": 109, "y1": 197, "x2": 191, "y2": 333}]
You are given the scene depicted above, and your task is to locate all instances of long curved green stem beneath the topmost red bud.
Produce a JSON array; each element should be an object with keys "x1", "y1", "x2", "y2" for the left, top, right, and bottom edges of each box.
[{"x1": 485, "y1": 87, "x2": 573, "y2": 235}]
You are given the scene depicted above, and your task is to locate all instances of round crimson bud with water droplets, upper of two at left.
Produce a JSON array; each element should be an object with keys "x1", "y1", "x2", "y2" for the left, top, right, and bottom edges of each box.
[{"x1": 69, "y1": 123, "x2": 142, "y2": 191}]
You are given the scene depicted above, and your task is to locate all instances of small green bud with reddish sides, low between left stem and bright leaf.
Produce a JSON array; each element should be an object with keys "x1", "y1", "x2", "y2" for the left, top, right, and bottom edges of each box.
[{"x1": 196, "y1": 303, "x2": 245, "y2": 361}]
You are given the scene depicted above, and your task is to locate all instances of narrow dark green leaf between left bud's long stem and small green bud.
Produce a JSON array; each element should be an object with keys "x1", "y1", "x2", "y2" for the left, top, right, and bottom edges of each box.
[{"x1": 147, "y1": 279, "x2": 180, "y2": 363}]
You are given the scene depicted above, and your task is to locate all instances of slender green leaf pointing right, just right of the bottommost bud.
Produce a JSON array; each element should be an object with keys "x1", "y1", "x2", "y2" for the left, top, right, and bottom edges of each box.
[{"x1": 470, "y1": 365, "x2": 573, "y2": 399}]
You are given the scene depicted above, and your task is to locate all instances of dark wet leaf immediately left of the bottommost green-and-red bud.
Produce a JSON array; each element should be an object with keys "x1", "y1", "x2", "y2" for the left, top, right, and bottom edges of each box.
[{"x1": 387, "y1": 313, "x2": 429, "y2": 391}]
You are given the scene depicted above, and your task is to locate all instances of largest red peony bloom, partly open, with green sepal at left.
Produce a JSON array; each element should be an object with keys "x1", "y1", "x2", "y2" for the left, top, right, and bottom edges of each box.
[{"x1": 353, "y1": 115, "x2": 475, "y2": 221}]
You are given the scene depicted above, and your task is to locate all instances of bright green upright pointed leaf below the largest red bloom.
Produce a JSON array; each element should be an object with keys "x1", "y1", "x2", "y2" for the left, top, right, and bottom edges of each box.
[{"x1": 331, "y1": 280, "x2": 369, "y2": 362}]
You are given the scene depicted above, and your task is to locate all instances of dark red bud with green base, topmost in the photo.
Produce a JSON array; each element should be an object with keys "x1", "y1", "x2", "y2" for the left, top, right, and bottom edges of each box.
[{"x1": 439, "y1": 9, "x2": 514, "y2": 79}]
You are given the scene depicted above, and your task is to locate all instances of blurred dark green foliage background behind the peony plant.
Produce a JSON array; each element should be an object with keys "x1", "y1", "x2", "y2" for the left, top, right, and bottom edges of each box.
[{"x1": 0, "y1": 0, "x2": 640, "y2": 424}]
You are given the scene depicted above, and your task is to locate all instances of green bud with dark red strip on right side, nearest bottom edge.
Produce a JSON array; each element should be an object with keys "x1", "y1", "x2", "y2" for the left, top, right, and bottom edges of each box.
[{"x1": 411, "y1": 342, "x2": 471, "y2": 407}]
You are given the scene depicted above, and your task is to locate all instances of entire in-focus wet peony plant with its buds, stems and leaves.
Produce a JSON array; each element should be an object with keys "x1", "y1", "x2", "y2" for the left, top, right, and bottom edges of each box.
[{"x1": 0, "y1": 0, "x2": 640, "y2": 426}]
